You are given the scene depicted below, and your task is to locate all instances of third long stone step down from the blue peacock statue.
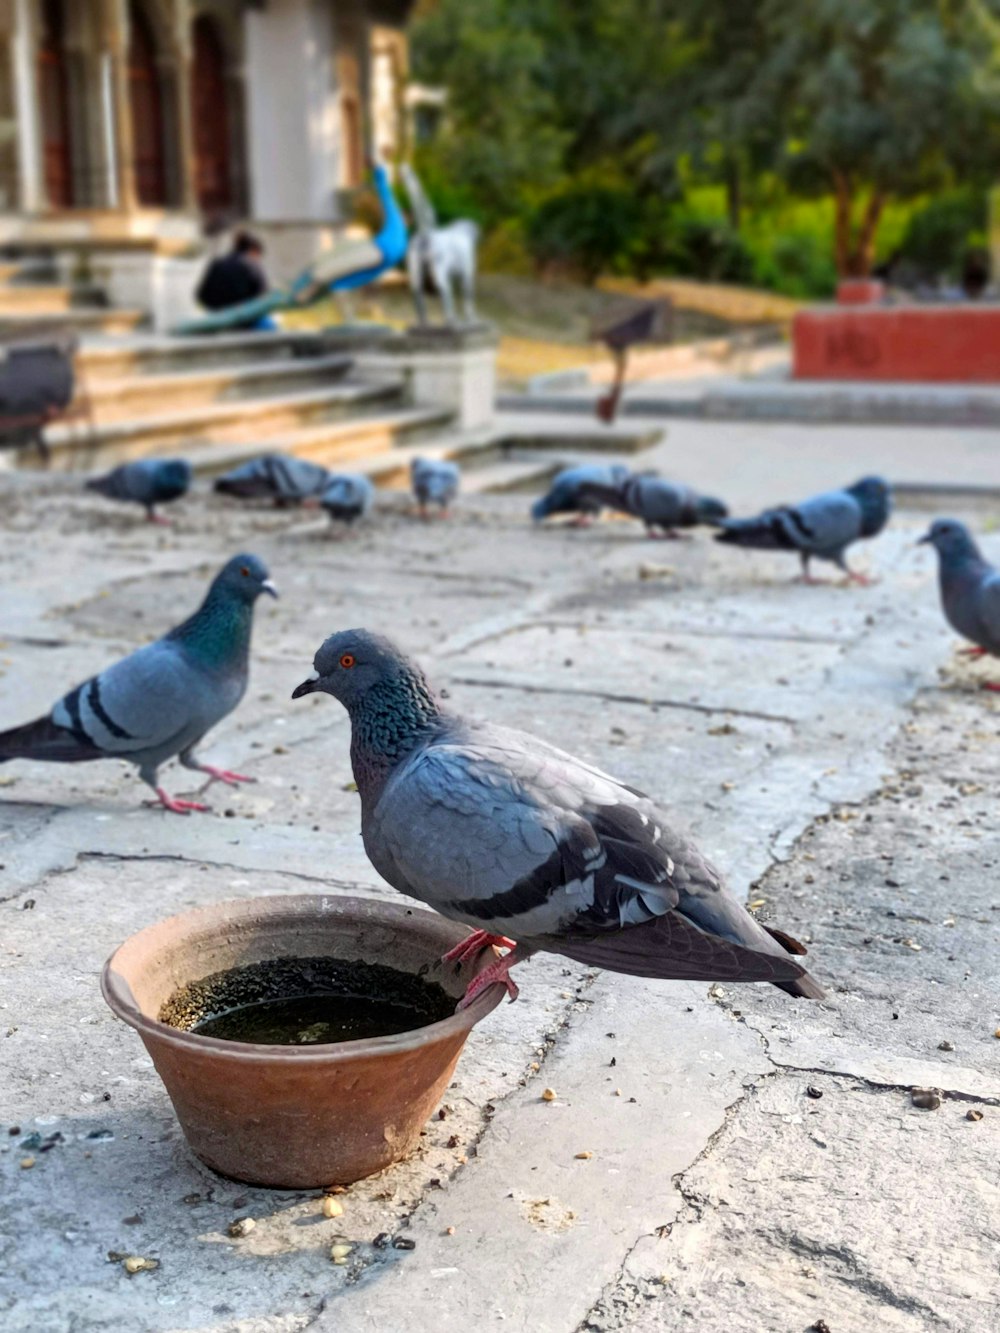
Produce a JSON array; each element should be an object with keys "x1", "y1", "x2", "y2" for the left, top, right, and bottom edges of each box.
[{"x1": 39, "y1": 384, "x2": 401, "y2": 468}]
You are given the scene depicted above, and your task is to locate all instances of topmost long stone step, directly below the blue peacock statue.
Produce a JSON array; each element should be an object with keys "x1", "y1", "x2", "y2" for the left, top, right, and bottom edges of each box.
[{"x1": 79, "y1": 331, "x2": 331, "y2": 384}]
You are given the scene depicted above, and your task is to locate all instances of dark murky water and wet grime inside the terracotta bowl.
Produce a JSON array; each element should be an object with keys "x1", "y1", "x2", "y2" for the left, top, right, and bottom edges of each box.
[{"x1": 159, "y1": 958, "x2": 455, "y2": 1046}]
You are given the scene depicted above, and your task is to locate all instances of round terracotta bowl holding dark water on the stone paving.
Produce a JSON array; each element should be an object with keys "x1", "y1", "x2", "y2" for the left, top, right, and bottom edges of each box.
[{"x1": 101, "y1": 894, "x2": 504, "y2": 1189}]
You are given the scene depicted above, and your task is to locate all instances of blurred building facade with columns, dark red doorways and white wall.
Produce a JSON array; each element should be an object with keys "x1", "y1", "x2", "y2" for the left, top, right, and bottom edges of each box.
[{"x1": 0, "y1": 0, "x2": 412, "y2": 239}]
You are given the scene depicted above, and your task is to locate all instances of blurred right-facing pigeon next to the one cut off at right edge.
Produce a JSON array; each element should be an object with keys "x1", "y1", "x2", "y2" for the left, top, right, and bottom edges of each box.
[{"x1": 715, "y1": 477, "x2": 892, "y2": 584}]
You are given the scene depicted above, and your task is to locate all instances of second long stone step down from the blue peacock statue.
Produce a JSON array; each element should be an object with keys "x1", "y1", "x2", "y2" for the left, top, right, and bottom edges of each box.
[{"x1": 81, "y1": 356, "x2": 352, "y2": 423}]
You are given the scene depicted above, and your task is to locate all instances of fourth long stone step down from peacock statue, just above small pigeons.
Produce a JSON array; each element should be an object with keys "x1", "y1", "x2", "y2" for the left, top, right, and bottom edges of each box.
[{"x1": 191, "y1": 408, "x2": 461, "y2": 481}]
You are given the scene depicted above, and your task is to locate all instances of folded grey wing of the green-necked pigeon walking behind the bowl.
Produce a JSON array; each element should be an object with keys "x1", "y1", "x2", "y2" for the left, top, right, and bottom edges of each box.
[{"x1": 51, "y1": 640, "x2": 209, "y2": 758}]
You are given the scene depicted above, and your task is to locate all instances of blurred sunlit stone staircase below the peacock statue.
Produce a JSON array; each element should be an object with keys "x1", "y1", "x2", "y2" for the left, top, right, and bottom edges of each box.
[{"x1": 0, "y1": 255, "x2": 661, "y2": 493}]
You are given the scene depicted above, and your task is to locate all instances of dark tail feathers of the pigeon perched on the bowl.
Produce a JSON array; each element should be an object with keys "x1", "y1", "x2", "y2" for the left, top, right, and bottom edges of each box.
[{"x1": 520, "y1": 912, "x2": 824, "y2": 1000}]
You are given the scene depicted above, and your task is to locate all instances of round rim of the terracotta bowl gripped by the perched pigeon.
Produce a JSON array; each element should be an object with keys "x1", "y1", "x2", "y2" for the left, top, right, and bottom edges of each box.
[{"x1": 101, "y1": 893, "x2": 505, "y2": 1064}]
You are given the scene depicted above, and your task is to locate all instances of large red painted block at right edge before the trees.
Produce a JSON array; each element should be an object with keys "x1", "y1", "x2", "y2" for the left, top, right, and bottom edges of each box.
[{"x1": 792, "y1": 303, "x2": 1000, "y2": 384}]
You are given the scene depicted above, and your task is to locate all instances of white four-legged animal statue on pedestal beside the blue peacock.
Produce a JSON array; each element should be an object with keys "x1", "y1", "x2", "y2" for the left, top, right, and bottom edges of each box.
[{"x1": 400, "y1": 163, "x2": 479, "y2": 325}]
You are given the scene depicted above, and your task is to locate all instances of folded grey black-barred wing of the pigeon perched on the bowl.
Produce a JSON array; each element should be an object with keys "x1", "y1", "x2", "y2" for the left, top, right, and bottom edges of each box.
[{"x1": 365, "y1": 728, "x2": 816, "y2": 980}]
